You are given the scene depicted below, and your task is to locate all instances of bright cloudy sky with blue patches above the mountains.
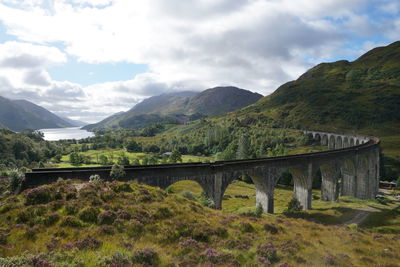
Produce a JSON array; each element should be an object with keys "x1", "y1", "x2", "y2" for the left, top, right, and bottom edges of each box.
[{"x1": 0, "y1": 0, "x2": 400, "y2": 123}]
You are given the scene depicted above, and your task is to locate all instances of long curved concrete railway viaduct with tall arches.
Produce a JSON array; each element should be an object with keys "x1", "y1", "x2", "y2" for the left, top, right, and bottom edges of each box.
[{"x1": 23, "y1": 131, "x2": 380, "y2": 213}]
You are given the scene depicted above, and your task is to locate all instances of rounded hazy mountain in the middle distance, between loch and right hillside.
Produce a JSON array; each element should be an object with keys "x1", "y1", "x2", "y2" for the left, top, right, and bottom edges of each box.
[{"x1": 84, "y1": 86, "x2": 262, "y2": 130}]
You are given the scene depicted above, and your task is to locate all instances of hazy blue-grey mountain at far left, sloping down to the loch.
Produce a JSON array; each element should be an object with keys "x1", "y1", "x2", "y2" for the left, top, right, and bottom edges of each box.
[{"x1": 0, "y1": 96, "x2": 72, "y2": 131}]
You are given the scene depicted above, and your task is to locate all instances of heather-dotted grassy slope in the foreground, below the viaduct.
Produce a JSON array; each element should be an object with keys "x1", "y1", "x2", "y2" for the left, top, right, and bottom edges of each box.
[{"x1": 0, "y1": 181, "x2": 400, "y2": 266}]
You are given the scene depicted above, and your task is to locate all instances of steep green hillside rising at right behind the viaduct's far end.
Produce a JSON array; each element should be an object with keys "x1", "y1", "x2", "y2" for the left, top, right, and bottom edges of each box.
[{"x1": 236, "y1": 42, "x2": 400, "y2": 132}]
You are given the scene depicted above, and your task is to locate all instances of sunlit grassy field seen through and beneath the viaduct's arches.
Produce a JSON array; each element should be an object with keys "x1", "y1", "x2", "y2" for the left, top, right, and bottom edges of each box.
[{"x1": 169, "y1": 181, "x2": 400, "y2": 226}]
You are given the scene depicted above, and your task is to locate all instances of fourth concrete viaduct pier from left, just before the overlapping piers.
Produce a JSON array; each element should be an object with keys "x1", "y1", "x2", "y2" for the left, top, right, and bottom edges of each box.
[{"x1": 321, "y1": 162, "x2": 340, "y2": 201}]
